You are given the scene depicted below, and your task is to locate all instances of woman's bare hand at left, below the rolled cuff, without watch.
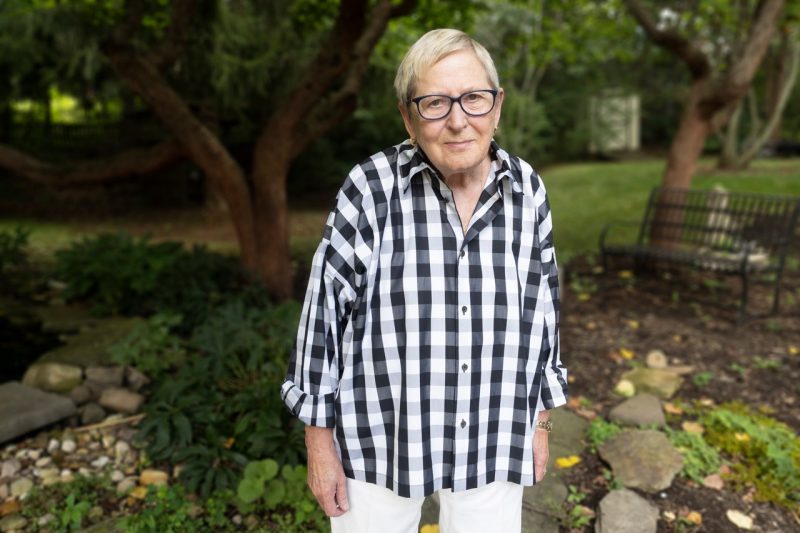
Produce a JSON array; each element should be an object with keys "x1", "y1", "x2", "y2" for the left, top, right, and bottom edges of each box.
[{"x1": 306, "y1": 426, "x2": 350, "y2": 516}]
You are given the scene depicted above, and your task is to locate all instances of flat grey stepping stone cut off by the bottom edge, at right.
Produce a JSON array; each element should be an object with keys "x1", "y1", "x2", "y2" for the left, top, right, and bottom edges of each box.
[{"x1": 594, "y1": 489, "x2": 658, "y2": 533}]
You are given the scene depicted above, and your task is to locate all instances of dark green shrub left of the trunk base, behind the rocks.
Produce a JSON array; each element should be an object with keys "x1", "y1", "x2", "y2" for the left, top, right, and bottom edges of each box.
[{"x1": 55, "y1": 233, "x2": 258, "y2": 332}]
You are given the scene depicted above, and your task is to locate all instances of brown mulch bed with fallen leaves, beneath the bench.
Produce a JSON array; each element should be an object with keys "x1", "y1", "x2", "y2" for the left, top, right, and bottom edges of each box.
[{"x1": 561, "y1": 258, "x2": 800, "y2": 532}]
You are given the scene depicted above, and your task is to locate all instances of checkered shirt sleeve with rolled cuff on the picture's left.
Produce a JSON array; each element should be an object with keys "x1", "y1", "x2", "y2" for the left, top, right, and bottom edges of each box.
[{"x1": 281, "y1": 173, "x2": 371, "y2": 428}]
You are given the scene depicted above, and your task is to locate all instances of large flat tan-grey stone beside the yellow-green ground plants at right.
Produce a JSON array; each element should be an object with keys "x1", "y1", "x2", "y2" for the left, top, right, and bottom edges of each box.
[{"x1": 599, "y1": 429, "x2": 683, "y2": 493}]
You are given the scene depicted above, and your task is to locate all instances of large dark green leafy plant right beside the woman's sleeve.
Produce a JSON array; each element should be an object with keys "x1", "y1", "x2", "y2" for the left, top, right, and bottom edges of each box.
[{"x1": 139, "y1": 301, "x2": 304, "y2": 495}]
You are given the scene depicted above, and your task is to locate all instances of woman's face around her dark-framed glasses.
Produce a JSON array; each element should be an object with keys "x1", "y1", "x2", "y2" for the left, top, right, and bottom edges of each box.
[{"x1": 400, "y1": 50, "x2": 503, "y2": 183}]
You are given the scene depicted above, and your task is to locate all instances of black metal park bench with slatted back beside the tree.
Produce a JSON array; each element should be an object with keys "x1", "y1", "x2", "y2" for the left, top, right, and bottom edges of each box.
[{"x1": 600, "y1": 187, "x2": 800, "y2": 321}]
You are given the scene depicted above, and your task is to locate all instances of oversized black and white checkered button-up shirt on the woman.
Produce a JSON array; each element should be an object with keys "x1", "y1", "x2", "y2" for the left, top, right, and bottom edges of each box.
[{"x1": 282, "y1": 141, "x2": 567, "y2": 497}]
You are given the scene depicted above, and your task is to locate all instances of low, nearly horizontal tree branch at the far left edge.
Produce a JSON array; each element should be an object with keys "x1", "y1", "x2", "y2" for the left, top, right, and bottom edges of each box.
[{"x1": 0, "y1": 139, "x2": 186, "y2": 186}]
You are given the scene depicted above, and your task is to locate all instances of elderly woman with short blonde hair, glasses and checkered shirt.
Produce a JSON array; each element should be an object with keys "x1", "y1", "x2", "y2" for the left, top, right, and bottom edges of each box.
[{"x1": 282, "y1": 30, "x2": 567, "y2": 533}]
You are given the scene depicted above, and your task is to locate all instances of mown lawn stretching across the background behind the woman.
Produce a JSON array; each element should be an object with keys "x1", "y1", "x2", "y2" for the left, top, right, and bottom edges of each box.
[{"x1": 0, "y1": 159, "x2": 800, "y2": 264}]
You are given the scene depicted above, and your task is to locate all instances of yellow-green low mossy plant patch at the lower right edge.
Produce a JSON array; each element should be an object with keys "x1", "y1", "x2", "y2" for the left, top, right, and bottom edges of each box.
[{"x1": 700, "y1": 403, "x2": 800, "y2": 508}]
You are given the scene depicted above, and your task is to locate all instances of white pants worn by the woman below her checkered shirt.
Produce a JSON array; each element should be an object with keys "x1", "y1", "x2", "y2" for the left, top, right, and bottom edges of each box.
[{"x1": 331, "y1": 479, "x2": 522, "y2": 533}]
